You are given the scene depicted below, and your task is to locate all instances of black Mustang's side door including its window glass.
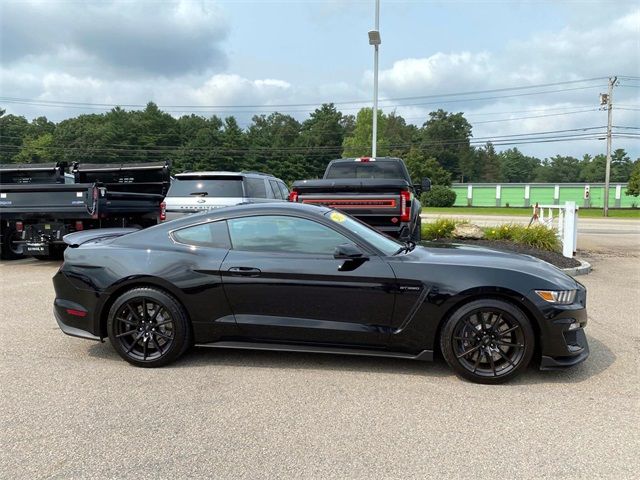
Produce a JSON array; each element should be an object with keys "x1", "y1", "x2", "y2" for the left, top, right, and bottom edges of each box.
[{"x1": 220, "y1": 215, "x2": 395, "y2": 346}]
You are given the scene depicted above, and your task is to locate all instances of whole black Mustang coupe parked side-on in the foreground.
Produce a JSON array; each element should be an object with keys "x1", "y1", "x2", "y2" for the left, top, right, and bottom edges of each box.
[{"x1": 53, "y1": 204, "x2": 589, "y2": 383}]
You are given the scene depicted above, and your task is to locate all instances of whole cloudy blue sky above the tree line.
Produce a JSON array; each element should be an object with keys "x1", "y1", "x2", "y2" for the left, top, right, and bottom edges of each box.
[{"x1": 0, "y1": 0, "x2": 640, "y2": 158}]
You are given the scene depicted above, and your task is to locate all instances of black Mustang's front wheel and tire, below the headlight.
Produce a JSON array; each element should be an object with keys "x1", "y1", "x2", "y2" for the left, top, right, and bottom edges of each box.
[{"x1": 440, "y1": 299, "x2": 535, "y2": 384}]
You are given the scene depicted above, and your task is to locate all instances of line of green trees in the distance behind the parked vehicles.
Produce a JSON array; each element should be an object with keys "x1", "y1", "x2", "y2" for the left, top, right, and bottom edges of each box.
[{"x1": 0, "y1": 103, "x2": 640, "y2": 189}]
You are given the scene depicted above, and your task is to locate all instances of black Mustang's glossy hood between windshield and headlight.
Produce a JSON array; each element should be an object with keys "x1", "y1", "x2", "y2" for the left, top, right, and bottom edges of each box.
[{"x1": 403, "y1": 244, "x2": 578, "y2": 289}]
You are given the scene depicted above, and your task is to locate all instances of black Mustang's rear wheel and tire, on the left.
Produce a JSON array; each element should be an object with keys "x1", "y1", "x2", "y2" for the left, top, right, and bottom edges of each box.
[{"x1": 107, "y1": 287, "x2": 192, "y2": 368}]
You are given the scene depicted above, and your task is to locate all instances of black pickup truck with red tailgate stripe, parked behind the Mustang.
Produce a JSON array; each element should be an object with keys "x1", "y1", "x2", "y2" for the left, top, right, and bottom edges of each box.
[{"x1": 289, "y1": 157, "x2": 431, "y2": 242}]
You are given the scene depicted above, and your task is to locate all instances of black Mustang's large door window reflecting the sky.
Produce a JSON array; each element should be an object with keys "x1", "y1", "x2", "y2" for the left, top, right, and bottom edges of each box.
[{"x1": 228, "y1": 215, "x2": 353, "y2": 255}]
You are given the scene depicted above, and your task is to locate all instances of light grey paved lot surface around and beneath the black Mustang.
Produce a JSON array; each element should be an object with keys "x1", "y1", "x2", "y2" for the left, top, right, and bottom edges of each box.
[{"x1": 0, "y1": 250, "x2": 640, "y2": 479}]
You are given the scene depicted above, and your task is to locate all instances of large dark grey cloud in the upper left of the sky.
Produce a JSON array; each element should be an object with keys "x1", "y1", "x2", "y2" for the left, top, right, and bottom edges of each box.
[{"x1": 0, "y1": 0, "x2": 228, "y2": 76}]
